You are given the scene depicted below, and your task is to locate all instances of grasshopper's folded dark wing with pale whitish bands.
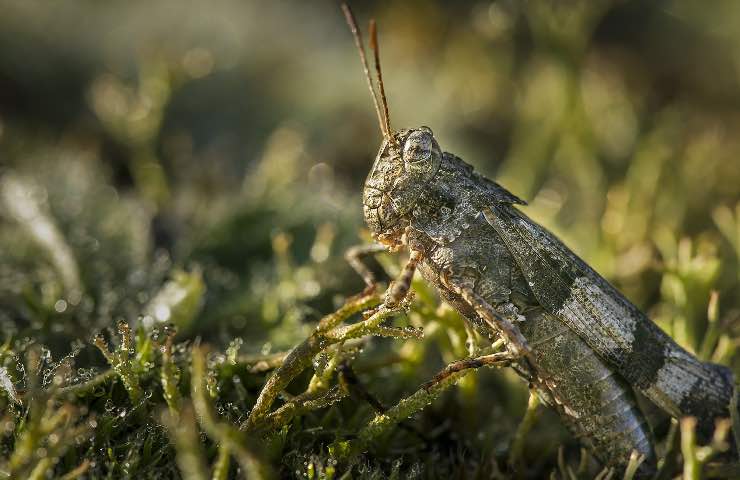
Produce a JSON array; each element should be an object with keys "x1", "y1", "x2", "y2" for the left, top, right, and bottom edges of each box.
[{"x1": 483, "y1": 202, "x2": 733, "y2": 428}]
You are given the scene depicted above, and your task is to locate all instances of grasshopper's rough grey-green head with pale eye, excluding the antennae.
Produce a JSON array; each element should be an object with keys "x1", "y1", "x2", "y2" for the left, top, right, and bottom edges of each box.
[{"x1": 362, "y1": 127, "x2": 442, "y2": 245}]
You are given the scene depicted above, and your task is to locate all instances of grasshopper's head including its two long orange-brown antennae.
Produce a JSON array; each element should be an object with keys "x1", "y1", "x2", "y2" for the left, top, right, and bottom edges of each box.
[{"x1": 342, "y1": 4, "x2": 442, "y2": 244}]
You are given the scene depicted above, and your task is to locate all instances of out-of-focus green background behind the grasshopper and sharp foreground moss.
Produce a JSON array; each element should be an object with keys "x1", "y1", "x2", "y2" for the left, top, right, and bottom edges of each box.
[{"x1": 0, "y1": 0, "x2": 740, "y2": 475}]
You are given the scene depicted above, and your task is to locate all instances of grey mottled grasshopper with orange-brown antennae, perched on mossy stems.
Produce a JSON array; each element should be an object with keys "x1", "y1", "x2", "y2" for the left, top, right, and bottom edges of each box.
[{"x1": 342, "y1": 5, "x2": 734, "y2": 477}]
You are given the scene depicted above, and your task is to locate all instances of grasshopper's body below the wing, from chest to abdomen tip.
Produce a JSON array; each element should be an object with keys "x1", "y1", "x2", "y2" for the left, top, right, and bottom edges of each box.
[{"x1": 415, "y1": 208, "x2": 655, "y2": 476}]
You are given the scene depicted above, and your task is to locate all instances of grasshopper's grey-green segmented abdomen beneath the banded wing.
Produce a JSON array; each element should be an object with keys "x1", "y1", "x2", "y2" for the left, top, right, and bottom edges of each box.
[{"x1": 519, "y1": 309, "x2": 655, "y2": 474}]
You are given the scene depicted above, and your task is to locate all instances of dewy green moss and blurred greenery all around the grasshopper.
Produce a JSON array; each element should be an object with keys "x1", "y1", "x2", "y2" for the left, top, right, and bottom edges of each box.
[{"x1": 0, "y1": 0, "x2": 740, "y2": 479}]
